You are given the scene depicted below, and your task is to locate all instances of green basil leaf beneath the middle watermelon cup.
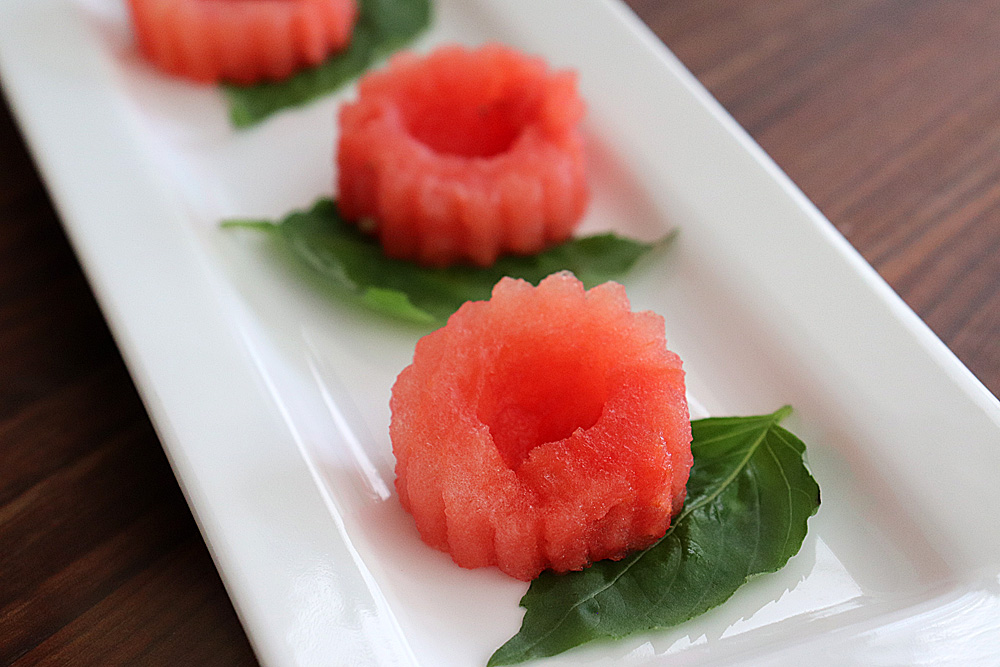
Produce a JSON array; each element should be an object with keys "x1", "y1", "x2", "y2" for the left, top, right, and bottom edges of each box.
[{"x1": 222, "y1": 199, "x2": 671, "y2": 323}]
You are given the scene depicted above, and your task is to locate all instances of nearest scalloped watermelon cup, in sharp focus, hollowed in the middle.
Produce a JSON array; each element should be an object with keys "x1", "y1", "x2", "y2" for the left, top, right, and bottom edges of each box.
[{"x1": 389, "y1": 272, "x2": 692, "y2": 581}]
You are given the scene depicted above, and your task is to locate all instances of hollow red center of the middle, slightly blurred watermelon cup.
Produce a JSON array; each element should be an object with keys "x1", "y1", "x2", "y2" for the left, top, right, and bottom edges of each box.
[{"x1": 404, "y1": 82, "x2": 539, "y2": 158}]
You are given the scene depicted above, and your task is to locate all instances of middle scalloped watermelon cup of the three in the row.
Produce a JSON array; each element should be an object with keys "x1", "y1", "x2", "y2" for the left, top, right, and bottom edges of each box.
[{"x1": 337, "y1": 44, "x2": 588, "y2": 267}]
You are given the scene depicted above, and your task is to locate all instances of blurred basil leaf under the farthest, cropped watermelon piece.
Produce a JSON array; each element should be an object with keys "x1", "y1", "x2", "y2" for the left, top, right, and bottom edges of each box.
[{"x1": 223, "y1": 0, "x2": 431, "y2": 127}]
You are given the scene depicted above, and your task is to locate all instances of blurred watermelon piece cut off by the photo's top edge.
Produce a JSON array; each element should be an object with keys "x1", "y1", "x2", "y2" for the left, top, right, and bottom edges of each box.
[{"x1": 129, "y1": 0, "x2": 358, "y2": 84}]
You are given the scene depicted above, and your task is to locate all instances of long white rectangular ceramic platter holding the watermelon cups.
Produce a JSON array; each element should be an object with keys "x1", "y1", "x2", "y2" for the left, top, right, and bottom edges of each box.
[{"x1": 0, "y1": 0, "x2": 1000, "y2": 667}]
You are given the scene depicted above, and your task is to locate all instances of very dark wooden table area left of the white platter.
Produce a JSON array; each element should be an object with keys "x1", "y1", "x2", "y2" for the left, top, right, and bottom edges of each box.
[{"x1": 0, "y1": 96, "x2": 255, "y2": 666}]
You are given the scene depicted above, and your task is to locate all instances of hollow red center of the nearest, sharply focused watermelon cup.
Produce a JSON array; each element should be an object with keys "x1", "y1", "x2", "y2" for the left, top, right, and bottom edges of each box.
[{"x1": 478, "y1": 340, "x2": 608, "y2": 470}]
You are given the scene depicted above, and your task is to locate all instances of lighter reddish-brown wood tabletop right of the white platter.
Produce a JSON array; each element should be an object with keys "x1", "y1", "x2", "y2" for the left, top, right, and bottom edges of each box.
[{"x1": 629, "y1": 0, "x2": 1000, "y2": 395}]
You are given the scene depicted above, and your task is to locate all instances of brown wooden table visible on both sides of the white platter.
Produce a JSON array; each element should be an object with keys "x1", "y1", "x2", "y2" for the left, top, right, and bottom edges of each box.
[{"x1": 0, "y1": 0, "x2": 1000, "y2": 665}]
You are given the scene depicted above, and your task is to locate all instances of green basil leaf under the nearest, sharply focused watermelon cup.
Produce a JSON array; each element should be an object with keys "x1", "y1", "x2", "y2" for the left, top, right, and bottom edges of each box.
[{"x1": 489, "y1": 406, "x2": 819, "y2": 667}]
